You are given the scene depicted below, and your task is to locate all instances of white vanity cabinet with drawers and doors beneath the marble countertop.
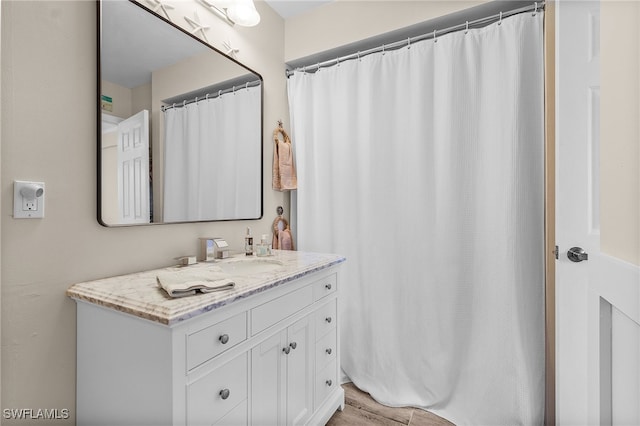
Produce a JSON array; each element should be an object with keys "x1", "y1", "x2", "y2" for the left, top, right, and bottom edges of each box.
[{"x1": 72, "y1": 253, "x2": 344, "y2": 426}]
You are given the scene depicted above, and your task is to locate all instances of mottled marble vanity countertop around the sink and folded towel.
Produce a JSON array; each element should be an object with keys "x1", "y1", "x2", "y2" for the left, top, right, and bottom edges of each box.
[{"x1": 66, "y1": 250, "x2": 345, "y2": 326}]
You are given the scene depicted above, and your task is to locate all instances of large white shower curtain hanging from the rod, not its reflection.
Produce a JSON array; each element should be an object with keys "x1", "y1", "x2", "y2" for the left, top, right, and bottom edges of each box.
[{"x1": 288, "y1": 12, "x2": 544, "y2": 425}]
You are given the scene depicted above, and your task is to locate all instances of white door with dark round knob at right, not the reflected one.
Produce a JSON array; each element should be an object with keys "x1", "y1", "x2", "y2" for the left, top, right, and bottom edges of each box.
[{"x1": 556, "y1": 0, "x2": 640, "y2": 425}]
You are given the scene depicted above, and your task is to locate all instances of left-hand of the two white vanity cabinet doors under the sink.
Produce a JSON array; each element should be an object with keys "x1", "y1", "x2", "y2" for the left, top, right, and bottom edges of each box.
[{"x1": 251, "y1": 331, "x2": 287, "y2": 426}]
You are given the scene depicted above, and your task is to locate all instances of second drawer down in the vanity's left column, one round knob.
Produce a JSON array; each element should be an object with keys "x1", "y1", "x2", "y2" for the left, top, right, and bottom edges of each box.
[{"x1": 187, "y1": 353, "x2": 248, "y2": 426}]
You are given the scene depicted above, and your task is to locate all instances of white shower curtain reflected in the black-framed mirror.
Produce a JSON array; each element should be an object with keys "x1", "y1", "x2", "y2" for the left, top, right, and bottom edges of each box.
[{"x1": 163, "y1": 86, "x2": 262, "y2": 222}]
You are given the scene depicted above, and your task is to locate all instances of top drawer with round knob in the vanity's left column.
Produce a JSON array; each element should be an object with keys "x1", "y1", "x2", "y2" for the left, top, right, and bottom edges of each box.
[{"x1": 187, "y1": 312, "x2": 247, "y2": 370}]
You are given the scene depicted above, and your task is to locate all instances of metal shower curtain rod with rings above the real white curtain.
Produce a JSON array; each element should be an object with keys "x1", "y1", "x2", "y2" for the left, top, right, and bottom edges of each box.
[{"x1": 285, "y1": 1, "x2": 545, "y2": 78}]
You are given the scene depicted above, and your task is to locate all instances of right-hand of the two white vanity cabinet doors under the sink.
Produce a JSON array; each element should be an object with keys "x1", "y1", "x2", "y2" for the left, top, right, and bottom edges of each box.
[{"x1": 286, "y1": 317, "x2": 314, "y2": 425}]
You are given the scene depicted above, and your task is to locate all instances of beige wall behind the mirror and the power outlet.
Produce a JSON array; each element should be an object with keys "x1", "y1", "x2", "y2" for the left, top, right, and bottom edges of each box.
[{"x1": 0, "y1": 1, "x2": 289, "y2": 424}]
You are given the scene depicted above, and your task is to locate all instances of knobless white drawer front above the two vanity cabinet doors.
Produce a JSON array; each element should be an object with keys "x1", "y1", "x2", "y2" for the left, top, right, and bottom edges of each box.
[{"x1": 251, "y1": 285, "x2": 313, "y2": 336}]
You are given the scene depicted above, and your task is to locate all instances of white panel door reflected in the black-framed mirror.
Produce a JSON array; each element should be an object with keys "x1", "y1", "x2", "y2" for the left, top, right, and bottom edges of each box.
[{"x1": 118, "y1": 110, "x2": 150, "y2": 224}]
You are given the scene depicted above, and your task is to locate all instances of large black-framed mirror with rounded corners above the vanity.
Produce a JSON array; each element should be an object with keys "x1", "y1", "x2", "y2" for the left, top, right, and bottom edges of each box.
[{"x1": 97, "y1": 0, "x2": 263, "y2": 226}]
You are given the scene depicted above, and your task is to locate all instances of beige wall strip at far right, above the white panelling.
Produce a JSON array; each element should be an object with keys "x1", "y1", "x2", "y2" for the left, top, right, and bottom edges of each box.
[{"x1": 600, "y1": 0, "x2": 640, "y2": 265}]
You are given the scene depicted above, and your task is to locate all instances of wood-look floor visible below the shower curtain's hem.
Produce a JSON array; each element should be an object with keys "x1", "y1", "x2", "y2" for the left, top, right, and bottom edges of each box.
[{"x1": 327, "y1": 383, "x2": 453, "y2": 426}]
